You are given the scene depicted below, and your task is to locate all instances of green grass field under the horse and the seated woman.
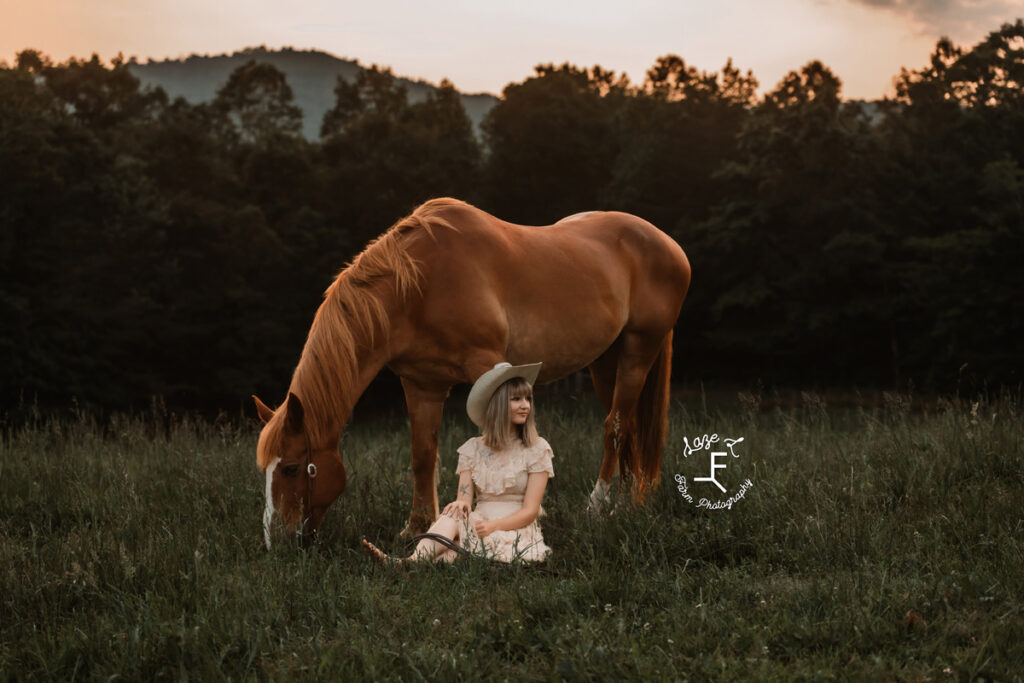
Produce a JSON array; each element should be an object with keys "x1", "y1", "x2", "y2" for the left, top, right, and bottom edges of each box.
[{"x1": 0, "y1": 394, "x2": 1024, "y2": 681}]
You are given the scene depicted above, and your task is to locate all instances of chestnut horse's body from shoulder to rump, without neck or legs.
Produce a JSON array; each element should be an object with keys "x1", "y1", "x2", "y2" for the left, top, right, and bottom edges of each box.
[{"x1": 391, "y1": 204, "x2": 689, "y2": 381}]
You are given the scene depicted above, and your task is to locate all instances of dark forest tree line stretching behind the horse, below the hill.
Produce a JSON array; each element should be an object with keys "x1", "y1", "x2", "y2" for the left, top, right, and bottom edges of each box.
[{"x1": 0, "y1": 19, "x2": 1024, "y2": 414}]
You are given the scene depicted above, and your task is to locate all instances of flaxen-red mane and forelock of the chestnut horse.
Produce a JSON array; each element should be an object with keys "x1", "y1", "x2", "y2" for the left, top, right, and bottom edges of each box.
[{"x1": 257, "y1": 198, "x2": 469, "y2": 469}]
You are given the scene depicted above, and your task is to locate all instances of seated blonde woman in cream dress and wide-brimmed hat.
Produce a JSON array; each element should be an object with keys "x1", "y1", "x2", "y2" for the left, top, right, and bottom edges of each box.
[{"x1": 362, "y1": 362, "x2": 555, "y2": 562}]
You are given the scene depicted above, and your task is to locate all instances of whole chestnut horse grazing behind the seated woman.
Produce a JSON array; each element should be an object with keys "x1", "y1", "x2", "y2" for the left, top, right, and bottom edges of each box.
[{"x1": 253, "y1": 199, "x2": 690, "y2": 548}]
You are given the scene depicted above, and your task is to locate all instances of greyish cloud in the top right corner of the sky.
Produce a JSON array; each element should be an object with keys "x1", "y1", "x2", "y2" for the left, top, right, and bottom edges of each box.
[{"x1": 850, "y1": 0, "x2": 1024, "y2": 44}]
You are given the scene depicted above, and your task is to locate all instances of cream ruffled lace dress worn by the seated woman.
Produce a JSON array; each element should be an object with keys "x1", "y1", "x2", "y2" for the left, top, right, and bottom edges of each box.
[{"x1": 456, "y1": 436, "x2": 555, "y2": 562}]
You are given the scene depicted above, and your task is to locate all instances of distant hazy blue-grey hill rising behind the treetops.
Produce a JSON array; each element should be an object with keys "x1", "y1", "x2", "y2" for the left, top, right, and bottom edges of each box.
[{"x1": 129, "y1": 47, "x2": 498, "y2": 140}]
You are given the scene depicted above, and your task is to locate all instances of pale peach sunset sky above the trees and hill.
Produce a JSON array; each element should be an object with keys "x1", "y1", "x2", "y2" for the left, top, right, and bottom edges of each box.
[{"x1": 0, "y1": 0, "x2": 1024, "y2": 99}]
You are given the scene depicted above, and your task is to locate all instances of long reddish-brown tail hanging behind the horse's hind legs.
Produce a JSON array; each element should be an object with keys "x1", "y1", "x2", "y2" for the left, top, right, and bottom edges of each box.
[{"x1": 635, "y1": 330, "x2": 672, "y2": 502}]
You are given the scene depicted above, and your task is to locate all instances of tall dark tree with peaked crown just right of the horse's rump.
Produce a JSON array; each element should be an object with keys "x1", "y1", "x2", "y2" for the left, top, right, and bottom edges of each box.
[{"x1": 688, "y1": 61, "x2": 891, "y2": 382}]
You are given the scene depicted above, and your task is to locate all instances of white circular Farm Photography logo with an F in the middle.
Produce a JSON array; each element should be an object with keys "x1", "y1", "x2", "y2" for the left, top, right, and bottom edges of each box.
[{"x1": 675, "y1": 434, "x2": 754, "y2": 510}]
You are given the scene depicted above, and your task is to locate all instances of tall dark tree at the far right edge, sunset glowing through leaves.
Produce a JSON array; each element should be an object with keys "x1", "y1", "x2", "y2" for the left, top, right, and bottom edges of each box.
[{"x1": 882, "y1": 19, "x2": 1024, "y2": 386}]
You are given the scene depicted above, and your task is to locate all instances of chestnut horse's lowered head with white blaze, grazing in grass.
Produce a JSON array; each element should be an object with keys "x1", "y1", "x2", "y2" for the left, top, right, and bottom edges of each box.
[{"x1": 253, "y1": 393, "x2": 345, "y2": 550}]
